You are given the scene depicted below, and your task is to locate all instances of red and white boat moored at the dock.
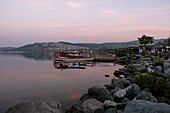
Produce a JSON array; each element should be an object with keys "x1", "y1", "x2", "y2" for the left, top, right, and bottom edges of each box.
[{"x1": 54, "y1": 52, "x2": 95, "y2": 61}]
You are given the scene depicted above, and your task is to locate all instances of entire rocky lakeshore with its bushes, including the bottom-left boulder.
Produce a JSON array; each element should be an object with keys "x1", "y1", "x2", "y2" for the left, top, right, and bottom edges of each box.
[{"x1": 6, "y1": 56, "x2": 170, "y2": 113}]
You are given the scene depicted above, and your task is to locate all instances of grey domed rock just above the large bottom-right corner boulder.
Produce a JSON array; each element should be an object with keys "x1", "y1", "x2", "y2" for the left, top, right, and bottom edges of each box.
[{"x1": 136, "y1": 91, "x2": 158, "y2": 102}]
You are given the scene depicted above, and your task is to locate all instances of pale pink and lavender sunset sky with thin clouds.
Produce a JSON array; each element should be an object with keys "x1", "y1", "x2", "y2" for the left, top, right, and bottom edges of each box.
[{"x1": 0, "y1": 0, "x2": 170, "y2": 47}]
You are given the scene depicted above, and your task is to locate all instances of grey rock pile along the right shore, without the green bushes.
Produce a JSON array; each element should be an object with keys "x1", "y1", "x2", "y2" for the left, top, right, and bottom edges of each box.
[{"x1": 66, "y1": 57, "x2": 170, "y2": 113}]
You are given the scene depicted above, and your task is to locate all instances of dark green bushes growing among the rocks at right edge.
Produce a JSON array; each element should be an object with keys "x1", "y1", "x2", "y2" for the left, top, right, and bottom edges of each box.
[{"x1": 136, "y1": 73, "x2": 170, "y2": 104}]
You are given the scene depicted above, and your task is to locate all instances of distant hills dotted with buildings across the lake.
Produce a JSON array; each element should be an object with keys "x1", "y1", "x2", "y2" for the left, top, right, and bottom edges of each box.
[{"x1": 3, "y1": 39, "x2": 167, "y2": 51}]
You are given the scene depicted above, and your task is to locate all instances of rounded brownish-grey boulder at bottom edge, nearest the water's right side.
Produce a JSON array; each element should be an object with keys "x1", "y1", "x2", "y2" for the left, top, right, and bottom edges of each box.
[{"x1": 80, "y1": 98, "x2": 104, "y2": 113}]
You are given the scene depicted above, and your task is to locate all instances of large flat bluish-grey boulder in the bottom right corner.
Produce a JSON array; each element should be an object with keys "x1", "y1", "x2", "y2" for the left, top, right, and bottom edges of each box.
[{"x1": 124, "y1": 100, "x2": 170, "y2": 113}]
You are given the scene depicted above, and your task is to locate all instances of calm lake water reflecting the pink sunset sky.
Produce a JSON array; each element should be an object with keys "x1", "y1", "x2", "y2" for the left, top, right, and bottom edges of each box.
[{"x1": 0, "y1": 53, "x2": 122, "y2": 113}]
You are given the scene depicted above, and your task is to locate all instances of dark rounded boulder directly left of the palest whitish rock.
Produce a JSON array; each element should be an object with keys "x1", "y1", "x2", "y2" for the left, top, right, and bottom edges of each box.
[{"x1": 98, "y1": 89, "x2": 114, "y2": 102}]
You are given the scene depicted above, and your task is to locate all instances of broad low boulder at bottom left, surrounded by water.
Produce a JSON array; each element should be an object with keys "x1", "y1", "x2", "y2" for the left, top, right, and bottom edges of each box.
[{"x1": 6, "y1": 101, "x2": 63, "y2": 113}]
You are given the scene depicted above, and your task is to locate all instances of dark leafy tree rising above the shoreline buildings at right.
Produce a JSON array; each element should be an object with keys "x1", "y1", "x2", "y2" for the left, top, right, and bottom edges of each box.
[{"x1": 138, "y1": 35, "x2": 154, "y2": 48}]
